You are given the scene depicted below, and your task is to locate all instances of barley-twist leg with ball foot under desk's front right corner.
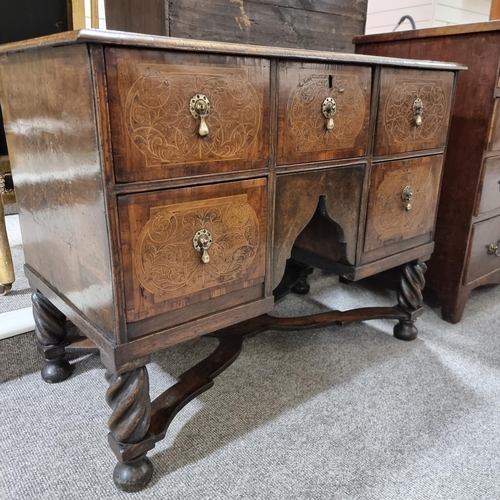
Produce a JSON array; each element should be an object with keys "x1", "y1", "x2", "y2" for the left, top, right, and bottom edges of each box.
[{"x1": 394, "y1": 262, "x2": 427, "y2": 340}]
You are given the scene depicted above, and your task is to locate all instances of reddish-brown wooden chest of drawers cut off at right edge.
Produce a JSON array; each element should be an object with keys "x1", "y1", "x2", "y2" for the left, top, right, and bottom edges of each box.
[{"x1": 354, "y1": 21, "x2": 500, "y2": 323}]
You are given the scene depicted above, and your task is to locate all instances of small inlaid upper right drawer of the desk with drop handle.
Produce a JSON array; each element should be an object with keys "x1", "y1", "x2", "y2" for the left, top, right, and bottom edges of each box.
[{"x1": 375, "y1": 68, "x2": 454, "y2": 155}]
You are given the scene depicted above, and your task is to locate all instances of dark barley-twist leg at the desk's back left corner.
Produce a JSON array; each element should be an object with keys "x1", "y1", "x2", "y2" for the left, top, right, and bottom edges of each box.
[{"x1": 31, "y1": 290, "x2": 73, "y2": 383}]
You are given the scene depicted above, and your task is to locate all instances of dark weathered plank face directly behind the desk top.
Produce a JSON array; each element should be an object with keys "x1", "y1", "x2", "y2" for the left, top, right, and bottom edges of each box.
[{"x1": 170, "y1": 0, "x2": 365, "y2": 52}]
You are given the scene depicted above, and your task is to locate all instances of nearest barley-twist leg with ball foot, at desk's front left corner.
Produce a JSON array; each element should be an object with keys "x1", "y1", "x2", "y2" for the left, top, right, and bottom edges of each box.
[{"x1": 106, "y1": 366, "x2": 154, "y2": 492}]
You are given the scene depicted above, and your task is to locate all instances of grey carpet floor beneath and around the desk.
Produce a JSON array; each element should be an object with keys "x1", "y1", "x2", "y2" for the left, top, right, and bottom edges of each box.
[{"x1": 0, "y1": 213, "x2": 500, "y2": 500}]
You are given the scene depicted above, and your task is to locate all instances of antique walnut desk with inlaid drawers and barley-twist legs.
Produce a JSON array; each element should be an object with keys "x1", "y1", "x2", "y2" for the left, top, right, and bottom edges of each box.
[{"x1": 0, "y1": 30, "x2": 463, "y2": 491}]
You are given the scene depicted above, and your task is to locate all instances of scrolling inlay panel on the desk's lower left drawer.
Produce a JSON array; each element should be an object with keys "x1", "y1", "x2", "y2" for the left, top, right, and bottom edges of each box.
[{"x1": 135, "y1": 194, "x2": 259, "y2": 302}]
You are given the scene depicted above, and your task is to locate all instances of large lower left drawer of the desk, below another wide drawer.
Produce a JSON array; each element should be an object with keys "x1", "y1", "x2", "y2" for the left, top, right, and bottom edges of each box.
[{"x1": 118, "y1": 179, "x2": 267, "y2": 323}]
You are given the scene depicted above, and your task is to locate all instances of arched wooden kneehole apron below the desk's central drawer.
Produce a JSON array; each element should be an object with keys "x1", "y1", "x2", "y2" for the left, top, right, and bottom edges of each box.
[{"x1": 273, "y1": 166, "x2": 365, "y2": 288}]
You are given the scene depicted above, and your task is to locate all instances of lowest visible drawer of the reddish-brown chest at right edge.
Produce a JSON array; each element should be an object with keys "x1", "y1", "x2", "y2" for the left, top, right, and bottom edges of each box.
[{"x1": 466, "y1": 217, "x2": 500, "y2": 284}]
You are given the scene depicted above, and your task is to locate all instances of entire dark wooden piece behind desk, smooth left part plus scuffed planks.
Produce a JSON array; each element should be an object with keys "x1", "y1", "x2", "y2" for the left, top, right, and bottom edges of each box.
[{"x1": 105, "y1": 0, "x2": 367, "y2": 52}]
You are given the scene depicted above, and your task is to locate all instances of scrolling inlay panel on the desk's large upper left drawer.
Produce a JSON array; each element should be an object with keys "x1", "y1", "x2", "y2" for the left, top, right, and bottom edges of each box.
[{"x1": 126, "y1": 65, "x2": 261, "y2": 167}]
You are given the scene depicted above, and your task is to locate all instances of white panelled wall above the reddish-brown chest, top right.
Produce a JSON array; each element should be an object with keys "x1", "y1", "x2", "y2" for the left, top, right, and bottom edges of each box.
[{"x1": 365, "y1": 0, "x2": 491, "y2": 35}]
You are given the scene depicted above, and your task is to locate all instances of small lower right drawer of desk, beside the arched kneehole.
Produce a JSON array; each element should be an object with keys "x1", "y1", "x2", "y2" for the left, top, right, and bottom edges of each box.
[{"x1": 364, "y1": 156, "x2": 443, "y2": 254}]
